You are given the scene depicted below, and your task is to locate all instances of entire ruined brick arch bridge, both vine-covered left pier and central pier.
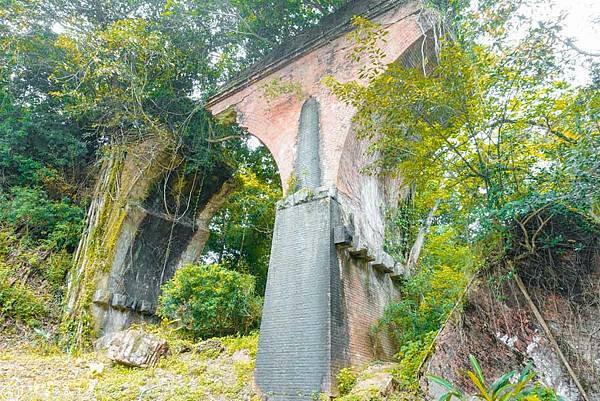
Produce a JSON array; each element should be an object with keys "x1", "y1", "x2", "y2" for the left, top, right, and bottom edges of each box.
[{"x1": 66, "y1": 0, "x2": 432, "y2": 401}]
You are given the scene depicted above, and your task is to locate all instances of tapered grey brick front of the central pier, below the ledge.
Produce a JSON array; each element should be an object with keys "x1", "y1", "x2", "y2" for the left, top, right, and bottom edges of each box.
[{"x1": 255, "y1": 189, "x2": 348, "y2": 401}]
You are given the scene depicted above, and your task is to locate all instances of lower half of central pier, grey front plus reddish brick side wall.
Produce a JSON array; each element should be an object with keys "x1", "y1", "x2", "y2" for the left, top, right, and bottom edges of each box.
[{"x1": 255, "y1": 187, "x2": 397, "y2": 401}]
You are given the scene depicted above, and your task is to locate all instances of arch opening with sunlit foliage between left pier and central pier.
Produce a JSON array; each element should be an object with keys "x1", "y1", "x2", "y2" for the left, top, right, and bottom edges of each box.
[{"x1": 199, "y1": 134, "x2": 282, "y2": 296}]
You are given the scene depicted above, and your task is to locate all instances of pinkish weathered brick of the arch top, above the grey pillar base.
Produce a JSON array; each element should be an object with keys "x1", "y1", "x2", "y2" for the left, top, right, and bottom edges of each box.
[{"x1": 209, "y1": 1, "x2": 428, "y2": 194}]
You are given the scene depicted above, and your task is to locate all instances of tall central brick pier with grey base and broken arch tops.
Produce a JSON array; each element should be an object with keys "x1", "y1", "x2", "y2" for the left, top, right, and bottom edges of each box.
[{"x1": 208, "y1": 0, "x2": 431, "y2": 401}]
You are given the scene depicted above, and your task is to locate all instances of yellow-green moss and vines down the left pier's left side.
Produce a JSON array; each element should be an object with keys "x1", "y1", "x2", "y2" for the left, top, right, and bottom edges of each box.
[{"x1": 60, "y1": 138, "x2": 183, "y2": 350}]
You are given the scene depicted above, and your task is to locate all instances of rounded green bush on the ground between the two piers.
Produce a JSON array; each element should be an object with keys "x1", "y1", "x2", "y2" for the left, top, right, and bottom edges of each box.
[{"x1": 158, "y1": 264, "x2": 261, "y2": 338}]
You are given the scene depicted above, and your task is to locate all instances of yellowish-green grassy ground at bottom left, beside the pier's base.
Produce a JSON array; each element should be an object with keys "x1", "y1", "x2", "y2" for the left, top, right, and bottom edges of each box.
[{"x1": 0, "y1": 335, "x2": 258, "y2": 401}]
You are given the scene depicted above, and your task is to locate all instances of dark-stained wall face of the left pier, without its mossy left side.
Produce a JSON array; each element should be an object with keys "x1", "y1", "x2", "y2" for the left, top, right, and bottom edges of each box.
[{"x1": 92, "y1": 162, "x2": 232, "y2": 335}]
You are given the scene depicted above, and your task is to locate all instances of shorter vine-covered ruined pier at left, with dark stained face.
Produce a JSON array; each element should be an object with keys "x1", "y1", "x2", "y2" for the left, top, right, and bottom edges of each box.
[{"x1": 64, "y1": 138, "x2": 235, "y2": 341}]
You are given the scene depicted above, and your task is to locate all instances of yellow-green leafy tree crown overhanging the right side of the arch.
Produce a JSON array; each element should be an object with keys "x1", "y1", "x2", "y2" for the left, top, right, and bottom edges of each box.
[{"x1": 329, "y1": 2, "x2": 599, "y2": 244}]
